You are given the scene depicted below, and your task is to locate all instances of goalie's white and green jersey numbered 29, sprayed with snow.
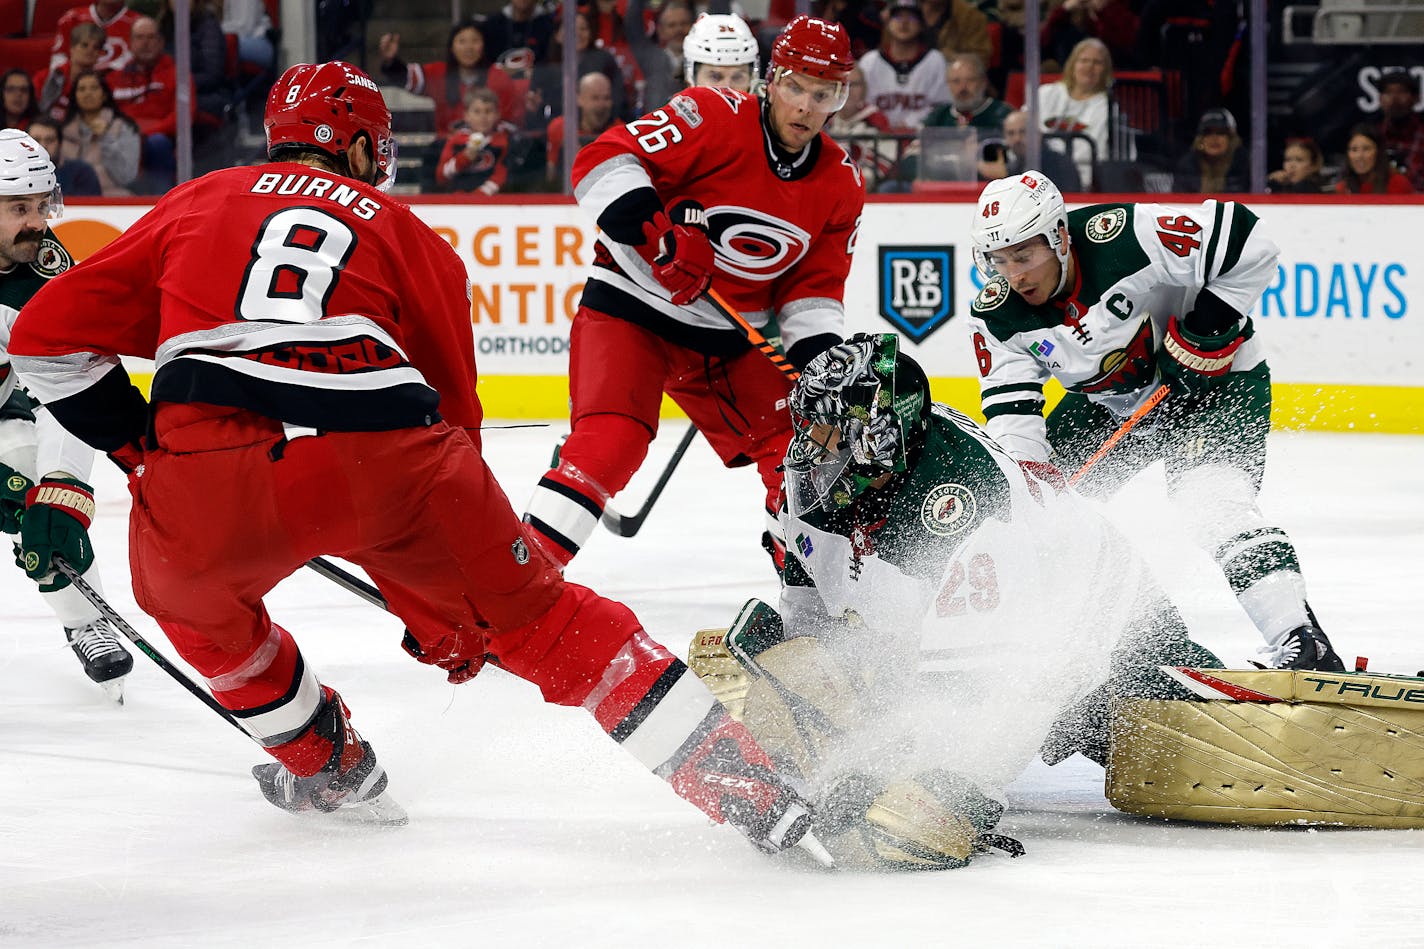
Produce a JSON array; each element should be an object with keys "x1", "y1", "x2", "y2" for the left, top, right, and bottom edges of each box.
[{"x1": 780, "y1": 405, "x2": 1161, "y2": 788}]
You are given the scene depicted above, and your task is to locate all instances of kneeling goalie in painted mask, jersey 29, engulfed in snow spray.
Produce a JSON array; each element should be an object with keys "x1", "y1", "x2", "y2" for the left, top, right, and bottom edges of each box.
[{"x1": 691, "y1": 333, "x2": 1219, "y2": 869}]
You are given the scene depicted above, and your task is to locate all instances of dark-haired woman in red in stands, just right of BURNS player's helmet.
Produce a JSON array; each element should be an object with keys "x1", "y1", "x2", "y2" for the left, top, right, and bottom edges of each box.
[{"x1": 379, "y1": 20, "x2": 524, "y2": 135}]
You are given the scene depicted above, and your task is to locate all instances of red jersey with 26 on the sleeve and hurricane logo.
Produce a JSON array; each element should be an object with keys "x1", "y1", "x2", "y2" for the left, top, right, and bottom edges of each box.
[{"x1": 572, "y1": 88, "x2": 864, "y2": 355}]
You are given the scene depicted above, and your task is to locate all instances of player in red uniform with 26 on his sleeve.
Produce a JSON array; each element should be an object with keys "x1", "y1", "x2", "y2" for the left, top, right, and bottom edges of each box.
[{"x1": 524, "y1": 16, "x2": 864, "y2": 564}]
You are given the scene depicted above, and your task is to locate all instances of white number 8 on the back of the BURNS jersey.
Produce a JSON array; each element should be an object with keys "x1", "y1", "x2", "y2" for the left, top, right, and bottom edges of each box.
[{"x1": 238, "y1": 208, "x2": 356, "y2": 323}]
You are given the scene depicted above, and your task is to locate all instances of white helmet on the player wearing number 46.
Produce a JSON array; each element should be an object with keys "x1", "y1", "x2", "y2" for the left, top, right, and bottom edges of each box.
[{"x1": 970, "y1": 171, "x2": 1069, "y2": 295}]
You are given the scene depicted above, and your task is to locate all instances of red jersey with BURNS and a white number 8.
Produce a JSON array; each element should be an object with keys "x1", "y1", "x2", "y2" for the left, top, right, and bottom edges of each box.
[{"x1": 11, "y1": 162, "x2": 481, "y2": 452}]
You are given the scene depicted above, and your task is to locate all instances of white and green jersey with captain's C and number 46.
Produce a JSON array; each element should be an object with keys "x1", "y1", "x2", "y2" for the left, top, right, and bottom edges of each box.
[{"x1": 970, "y1": 201, "x2": 1277, "y2": 460}]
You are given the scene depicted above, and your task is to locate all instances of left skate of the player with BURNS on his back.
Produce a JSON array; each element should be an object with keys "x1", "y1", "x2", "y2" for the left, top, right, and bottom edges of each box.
[{"x1": 252, "y1": 693, "x2": 410, "y2": 825}]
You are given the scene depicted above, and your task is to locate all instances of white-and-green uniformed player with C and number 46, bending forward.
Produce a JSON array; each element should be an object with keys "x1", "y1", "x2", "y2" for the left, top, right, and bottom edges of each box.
[{"x1": 970, "y1": 171, "x2": 1344, "y2": 671}]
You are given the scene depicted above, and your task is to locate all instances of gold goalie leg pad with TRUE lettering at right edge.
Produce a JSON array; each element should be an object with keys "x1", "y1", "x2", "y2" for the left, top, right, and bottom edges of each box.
[{"x1": 1106, "y1": 665, "x2": 1424, "y2": 828}]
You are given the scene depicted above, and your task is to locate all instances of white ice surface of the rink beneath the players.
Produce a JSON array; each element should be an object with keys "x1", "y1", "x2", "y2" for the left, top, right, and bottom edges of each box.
[{"x1": 0, "y1": 426, "x2": 1424, "y2": 949}]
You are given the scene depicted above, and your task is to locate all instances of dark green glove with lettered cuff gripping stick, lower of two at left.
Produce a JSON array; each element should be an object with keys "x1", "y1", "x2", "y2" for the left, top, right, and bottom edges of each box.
[{"x1": 16, "y1": 477, "x2": 94, "y2": 593}]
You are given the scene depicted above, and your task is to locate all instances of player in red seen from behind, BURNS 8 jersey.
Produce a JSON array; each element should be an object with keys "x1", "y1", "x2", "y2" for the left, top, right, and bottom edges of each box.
[{"x1": 11, "y1": 63, "x2": 810, "y2": 851}]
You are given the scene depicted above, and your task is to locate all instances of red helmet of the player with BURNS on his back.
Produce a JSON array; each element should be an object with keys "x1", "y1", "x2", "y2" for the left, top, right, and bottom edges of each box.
[{"x1": 266, "y1": 63, "x2": 396, "y2": 190}]
